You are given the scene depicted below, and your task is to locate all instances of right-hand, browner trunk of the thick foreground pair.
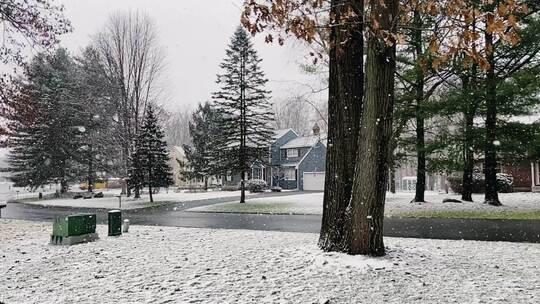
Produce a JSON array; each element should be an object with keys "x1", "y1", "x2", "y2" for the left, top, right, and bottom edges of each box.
[{"x1": 345, "y1": 0, "x2": 398, "y2": 256}]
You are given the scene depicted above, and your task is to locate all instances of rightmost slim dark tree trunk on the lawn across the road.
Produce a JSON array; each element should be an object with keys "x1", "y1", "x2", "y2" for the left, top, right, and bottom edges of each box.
[{"x1": 484, "y1": 27, "x2": 501, "y2": 206}]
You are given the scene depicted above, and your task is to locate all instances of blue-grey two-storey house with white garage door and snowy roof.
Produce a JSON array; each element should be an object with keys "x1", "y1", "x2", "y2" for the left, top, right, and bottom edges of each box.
[{"x1": 224, "y1": 125, "x2": 326, "y2": 191}]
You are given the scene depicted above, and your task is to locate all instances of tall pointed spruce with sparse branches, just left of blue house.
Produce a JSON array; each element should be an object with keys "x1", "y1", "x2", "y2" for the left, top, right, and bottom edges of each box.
[{"x1": 213, "y1": 27, "x2": 273, "y2": 203}]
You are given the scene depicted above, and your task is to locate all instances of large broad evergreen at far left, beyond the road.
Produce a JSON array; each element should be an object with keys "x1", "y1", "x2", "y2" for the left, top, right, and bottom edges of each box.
[{"x1": 8, "y1": 49, "x2": 86, "y2": 192}]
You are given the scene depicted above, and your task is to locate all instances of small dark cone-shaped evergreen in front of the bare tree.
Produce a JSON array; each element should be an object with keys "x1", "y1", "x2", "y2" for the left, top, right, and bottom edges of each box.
[{"x1": 129, "y1": 105, "x2": 173, "y2": 202}]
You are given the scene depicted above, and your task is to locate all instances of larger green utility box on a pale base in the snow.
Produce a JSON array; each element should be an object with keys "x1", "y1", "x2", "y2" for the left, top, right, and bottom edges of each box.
[{"x1": 51, "y1": 213, "x2": 98, "y2": 245}]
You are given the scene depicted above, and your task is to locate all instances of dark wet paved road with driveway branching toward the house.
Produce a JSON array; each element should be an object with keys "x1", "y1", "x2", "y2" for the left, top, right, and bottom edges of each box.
[{"x1": 2, "y1": 194, "x2": 540, "y2": 243}]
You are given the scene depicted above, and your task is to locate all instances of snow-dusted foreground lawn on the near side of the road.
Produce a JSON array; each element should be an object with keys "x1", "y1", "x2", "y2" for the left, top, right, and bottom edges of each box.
[{"x1": 0, "y1": 220, "x2": 540, "y2": 304}]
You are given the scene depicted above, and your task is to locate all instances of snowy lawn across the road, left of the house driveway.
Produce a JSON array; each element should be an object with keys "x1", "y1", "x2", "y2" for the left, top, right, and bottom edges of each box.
[{"x1": 5, "y1": 189, "x2": 255, "y2": 209}]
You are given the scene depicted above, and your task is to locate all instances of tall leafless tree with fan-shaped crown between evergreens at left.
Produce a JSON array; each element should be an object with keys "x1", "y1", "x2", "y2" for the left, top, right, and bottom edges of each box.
[{"x1": 94, "y1": 11, "x2": 163, "y2": 194}]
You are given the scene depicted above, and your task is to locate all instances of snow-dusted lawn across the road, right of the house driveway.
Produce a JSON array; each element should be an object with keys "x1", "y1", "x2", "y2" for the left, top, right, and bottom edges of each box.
[{"x1": 188, "y1": 191, "x2": 540, "y2": 216}]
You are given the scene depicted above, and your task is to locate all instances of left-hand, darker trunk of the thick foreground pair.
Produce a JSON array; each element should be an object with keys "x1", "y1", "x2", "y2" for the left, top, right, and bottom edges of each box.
[{"x1": 319, "y1": 0, "x2": 364, "y2": 251}]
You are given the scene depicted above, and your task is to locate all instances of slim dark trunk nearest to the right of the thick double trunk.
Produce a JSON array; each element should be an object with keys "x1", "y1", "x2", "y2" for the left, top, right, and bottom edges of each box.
[{"x1": 413, "y1": 11, "x2": 426, "y2": 202}]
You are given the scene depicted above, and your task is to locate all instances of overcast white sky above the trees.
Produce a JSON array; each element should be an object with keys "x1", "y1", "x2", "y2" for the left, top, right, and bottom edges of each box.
[{"x1": 56, "y1": 0, "x2": 324, "y2": 110}]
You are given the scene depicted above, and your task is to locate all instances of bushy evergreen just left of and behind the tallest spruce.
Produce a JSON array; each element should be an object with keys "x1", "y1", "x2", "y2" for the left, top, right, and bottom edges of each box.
[{"x1": 184, "y1": 102, "x2": 219, "y2": 190}]
